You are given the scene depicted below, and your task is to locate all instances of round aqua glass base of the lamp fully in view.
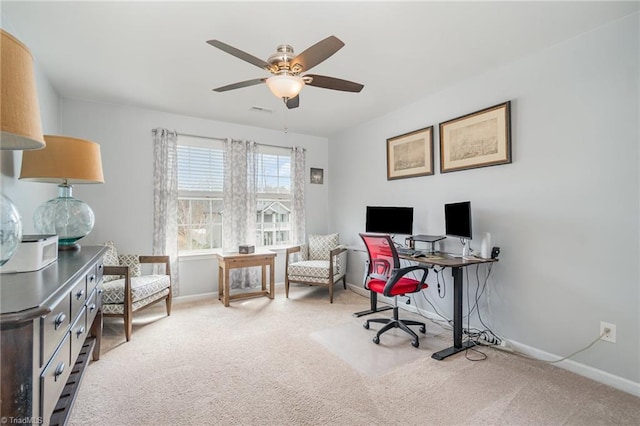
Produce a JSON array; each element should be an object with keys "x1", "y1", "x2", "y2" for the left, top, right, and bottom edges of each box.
[{"x1": 33, "y1": 184, "x2": 95, "y2": 250}]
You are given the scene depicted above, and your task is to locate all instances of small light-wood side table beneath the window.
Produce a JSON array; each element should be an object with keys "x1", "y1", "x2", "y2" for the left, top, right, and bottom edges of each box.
[{"x1": 216, "y1": 250, "x2": 276, "y2": 306}]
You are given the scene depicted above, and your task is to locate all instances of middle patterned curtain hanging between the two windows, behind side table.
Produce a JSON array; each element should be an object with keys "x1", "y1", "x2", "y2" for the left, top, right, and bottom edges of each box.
[{"x1": 222, "y1": 139, "x2": 261, "y2": 289}]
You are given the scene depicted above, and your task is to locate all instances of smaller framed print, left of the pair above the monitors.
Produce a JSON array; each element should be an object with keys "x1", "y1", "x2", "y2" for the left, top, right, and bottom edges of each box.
[{"x1": 387, "y1": 126, "x2": 433, "y2": 180}]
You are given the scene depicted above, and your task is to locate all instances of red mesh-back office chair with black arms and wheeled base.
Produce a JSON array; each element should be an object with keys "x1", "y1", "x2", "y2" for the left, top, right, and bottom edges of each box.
[{"x1": 360, "y1": 234, "x2": 429, "y2": 348}]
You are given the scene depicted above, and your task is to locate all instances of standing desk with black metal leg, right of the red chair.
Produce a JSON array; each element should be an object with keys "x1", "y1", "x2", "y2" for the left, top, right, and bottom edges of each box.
[{"x1": 399, "y1": 253, "x2": 498, "y2": 361}]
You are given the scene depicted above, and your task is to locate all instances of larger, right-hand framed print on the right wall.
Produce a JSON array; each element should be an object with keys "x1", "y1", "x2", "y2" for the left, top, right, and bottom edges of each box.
[{"x1": 440, "y1": 101, "x2": 511, "y2": 173}]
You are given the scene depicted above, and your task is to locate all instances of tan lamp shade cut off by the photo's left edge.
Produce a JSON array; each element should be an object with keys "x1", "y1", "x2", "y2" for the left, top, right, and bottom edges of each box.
[{"x1": 0, "y1": 29, "x2": 45, "y2": 150}]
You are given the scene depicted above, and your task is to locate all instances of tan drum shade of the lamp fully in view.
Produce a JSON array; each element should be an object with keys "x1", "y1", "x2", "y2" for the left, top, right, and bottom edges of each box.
[{"x1": 20, "y1": 135, "x2": 104, "y2": 184}]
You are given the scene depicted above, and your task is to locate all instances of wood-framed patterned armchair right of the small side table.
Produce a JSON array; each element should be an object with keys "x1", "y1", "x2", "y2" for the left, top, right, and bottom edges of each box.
[{"x1": 284, "y1": 234, "x2": 347, "y2": 303}]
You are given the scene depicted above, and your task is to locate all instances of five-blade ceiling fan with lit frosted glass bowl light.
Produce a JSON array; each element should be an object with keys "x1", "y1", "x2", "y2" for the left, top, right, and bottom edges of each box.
[{"x1": 207, "y1": 36, "x2": 364, "y2": 109}]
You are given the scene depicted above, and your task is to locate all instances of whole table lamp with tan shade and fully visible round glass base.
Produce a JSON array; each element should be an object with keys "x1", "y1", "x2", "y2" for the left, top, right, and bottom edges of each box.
[{"x1": 20, "y1": 135, "x2": 104, "y2": 250}]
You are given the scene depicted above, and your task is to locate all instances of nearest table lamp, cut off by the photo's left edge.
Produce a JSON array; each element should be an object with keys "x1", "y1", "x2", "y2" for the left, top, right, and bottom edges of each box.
[{"x1": 0, "y1": 29, "x2": 45, "y2": 266}]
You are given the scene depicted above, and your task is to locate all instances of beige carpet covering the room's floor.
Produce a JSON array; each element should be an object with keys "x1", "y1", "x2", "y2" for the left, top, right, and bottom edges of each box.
[{"x1": 70, "y1": 286, "x2": 640, "y2": 426}]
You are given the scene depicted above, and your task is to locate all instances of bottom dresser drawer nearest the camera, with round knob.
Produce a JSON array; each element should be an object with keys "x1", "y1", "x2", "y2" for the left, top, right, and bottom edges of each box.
[{"x1": 40, "y1": 334, "x2": 71, "y2": 422}]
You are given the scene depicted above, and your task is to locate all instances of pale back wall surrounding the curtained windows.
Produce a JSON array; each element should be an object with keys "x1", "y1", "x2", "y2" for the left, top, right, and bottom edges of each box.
[{"x1": 56, "y1": 99, "x2": 328, "y2": 296}]
